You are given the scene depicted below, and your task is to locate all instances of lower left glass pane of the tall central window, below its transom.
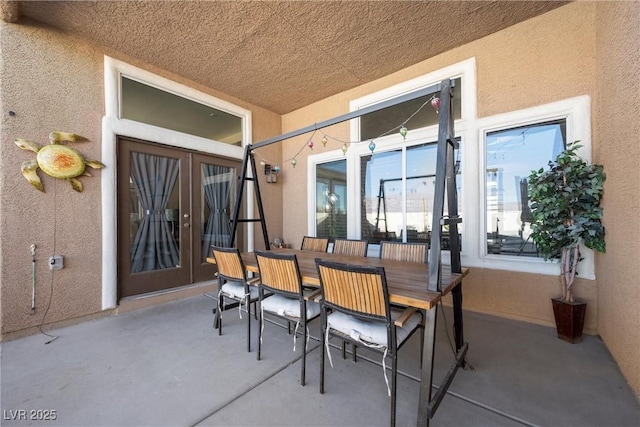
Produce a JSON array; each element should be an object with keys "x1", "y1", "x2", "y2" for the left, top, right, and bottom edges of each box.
[{"x1": 360, "y1": 150, "x2": 403, "y2": 244}]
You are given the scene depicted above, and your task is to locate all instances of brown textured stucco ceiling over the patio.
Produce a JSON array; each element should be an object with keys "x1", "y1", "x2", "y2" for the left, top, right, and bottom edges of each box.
[{"x1": 12, "y1": 1, "x2": 566, "y2": 114}]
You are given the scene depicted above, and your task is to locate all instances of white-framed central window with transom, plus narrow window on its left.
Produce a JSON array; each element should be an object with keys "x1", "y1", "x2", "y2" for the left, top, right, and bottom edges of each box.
[{"x1": 307, "y1": 59, "x2": 476, "y2": 256}]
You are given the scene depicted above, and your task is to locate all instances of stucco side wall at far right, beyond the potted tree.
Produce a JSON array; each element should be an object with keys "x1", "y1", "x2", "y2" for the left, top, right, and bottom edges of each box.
[{"x1": 594, "y1": 2, "x2": 640, "y2": 396}]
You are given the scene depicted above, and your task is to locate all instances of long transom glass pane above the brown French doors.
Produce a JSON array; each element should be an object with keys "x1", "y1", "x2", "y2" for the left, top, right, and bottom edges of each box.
[{"x1": 121, "y1": 76, "x2": 242, "y2": 147}]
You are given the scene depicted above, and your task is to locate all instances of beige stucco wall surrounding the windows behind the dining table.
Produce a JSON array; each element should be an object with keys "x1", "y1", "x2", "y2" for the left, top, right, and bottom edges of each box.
[{"x1": 283, "y1": 3, "x2": 598, "y2": 334}]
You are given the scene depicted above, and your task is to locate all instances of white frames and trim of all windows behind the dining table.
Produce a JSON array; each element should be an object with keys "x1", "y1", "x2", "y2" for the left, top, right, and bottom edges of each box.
[{"x1": 307, "y1": 58, "x2": 595, "y2": 280}]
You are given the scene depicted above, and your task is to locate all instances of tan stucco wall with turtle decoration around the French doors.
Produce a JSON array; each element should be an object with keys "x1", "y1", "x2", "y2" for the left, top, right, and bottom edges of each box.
[{"x1": 0, "y1": 22, "x2": 282, "y2": 339}]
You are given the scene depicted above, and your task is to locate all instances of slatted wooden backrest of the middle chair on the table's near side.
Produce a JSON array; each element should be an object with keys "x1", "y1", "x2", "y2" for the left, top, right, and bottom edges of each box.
[{"x1": 256, "y1": 251, "x2": 302, "y2": 294}]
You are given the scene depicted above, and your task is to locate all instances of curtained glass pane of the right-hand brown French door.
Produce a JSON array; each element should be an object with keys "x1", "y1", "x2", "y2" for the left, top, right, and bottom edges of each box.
[{"x1": 200, "y1": 163, "x2": 236, "y2": 262}]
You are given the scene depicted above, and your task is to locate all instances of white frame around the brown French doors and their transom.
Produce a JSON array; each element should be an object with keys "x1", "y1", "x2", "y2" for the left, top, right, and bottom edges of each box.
[{"x1": 101, "y1": 55, "x2": 254, "y2": 310}]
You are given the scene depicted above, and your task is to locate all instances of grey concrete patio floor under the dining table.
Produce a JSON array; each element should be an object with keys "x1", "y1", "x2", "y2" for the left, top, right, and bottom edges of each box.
[{"x1": 0, "y1": 296, "x2": 640, "y2": 426}]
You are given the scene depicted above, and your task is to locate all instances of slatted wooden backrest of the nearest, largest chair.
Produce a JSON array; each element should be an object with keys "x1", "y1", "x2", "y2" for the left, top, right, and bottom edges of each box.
[{"x1": 316, "y1": 260, "x2": 388, "y2": 317}]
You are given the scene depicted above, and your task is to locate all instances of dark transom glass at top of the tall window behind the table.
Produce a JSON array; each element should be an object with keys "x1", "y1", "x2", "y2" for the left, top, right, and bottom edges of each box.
[{"x1": 360, "y1": 78, "x2": 462, "y2": 141}]
